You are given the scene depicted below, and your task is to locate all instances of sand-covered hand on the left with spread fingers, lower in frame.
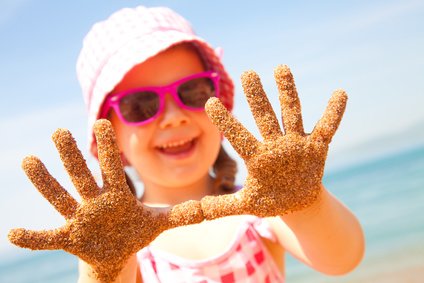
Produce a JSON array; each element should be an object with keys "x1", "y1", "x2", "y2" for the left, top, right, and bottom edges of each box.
[{"x1": 9, "y1": 120, "x2": 203, "y2": 282}]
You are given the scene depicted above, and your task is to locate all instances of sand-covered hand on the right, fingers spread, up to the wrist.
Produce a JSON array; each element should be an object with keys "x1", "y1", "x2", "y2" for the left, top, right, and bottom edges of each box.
[{"x1": 202, "y1": 65, "x2": 347, "y2": 219}]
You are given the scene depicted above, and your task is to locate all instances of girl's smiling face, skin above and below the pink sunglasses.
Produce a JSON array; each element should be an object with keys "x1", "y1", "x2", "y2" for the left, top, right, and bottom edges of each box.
[{"x1": 107, "y1": 46, "x2": 221, "y2": 189}]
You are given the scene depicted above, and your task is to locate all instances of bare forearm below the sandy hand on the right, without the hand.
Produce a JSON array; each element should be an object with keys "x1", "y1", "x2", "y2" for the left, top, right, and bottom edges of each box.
[{"x1": 270, "y1": 187, "x2": 364, "y2": 275}]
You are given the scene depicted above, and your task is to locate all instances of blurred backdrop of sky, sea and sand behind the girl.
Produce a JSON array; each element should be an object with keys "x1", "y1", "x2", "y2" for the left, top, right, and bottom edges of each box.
[{"x1": 0, "y1": 0, "x2": 424, "y2": 283}]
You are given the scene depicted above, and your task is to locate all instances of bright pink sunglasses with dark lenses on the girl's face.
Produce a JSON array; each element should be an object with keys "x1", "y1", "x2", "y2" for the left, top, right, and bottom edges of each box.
[{"x1": 99, "y1": 71, "x2": 219, "y2": 126}]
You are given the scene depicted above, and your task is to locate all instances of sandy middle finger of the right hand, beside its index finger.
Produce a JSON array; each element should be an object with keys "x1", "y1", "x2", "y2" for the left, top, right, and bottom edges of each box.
[{"x1": 241, "y1": 71, "x2": 282, "y2": 139}]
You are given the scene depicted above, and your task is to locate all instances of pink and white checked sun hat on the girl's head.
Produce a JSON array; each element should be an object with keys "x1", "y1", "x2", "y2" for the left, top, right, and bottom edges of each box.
[{"x1": 77, "y1": 6, "x2": 234, "y2": 156}]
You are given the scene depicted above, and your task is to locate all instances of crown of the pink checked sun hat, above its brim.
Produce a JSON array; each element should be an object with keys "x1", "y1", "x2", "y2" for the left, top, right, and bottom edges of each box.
[{"x1": 77, "y1": 6, "x2": 194, "y2": 107}]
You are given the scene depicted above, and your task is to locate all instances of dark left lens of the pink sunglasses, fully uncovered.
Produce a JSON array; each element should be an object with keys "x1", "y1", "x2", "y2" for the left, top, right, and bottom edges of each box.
[{"x1": 119, "y1": 91, "x2": 159, "y2": 122}]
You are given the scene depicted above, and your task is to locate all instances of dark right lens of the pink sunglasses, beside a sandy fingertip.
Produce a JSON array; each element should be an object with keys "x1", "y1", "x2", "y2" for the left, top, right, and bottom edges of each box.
[{"x1": 178, "y1": 78, "x2": 216, "y2": 109}]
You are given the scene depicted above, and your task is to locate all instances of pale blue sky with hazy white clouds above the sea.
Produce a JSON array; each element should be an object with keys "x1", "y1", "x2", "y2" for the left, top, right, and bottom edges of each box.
[{"x1": 0, "y1": 0, "x2": 424, "y2": 254}]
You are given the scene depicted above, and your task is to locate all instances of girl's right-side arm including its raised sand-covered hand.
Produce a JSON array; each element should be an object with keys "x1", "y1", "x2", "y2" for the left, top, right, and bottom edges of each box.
[{"x1": 202, "y1": 66, "x2": 364, "y2": 274}]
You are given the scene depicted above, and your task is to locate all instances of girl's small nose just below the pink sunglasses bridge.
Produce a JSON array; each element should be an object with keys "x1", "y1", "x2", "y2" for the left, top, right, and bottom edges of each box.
[{"x1": 159, "y1": 94, "x2": 189, "y2": 129}]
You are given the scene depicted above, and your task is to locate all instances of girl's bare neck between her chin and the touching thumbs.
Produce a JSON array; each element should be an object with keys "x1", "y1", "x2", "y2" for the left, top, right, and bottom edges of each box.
[{"x1": 141, "y1": 175, "x2": 214, "y2": 206}]
